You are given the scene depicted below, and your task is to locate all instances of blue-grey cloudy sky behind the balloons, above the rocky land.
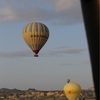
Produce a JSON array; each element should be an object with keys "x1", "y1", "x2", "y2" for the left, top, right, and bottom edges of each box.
[{"x1": 0, "y1": 0, "x2": 94, "y2": 90}]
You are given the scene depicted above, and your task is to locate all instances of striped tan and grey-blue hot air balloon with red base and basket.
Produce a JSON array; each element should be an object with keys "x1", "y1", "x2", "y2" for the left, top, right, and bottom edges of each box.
[{"x1": 22, "y1": 22, "x2": 49, "y2": 57}]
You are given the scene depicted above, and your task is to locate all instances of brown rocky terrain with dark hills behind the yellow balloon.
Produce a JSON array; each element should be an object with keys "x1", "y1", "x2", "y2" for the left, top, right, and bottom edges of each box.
[{"x1": 0, "y1": 88, "x2": 96, "y2": 100}]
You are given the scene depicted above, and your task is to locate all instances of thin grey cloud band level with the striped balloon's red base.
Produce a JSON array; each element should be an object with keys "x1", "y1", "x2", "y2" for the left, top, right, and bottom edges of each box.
[{"x1": 0, "y1": 47, "x2": 85, "y2": 58}]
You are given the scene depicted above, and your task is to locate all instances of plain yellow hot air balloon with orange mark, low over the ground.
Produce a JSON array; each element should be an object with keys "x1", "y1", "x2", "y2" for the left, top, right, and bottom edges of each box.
[{"x1": 64, "y1": 82, "x2": 81, "y2": 100}]
